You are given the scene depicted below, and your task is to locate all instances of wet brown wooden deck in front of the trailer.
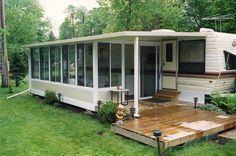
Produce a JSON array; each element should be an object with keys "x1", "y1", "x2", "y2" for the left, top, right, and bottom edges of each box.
[{"x1": 111, "y1": 104, "x2": 236, "y2": 148}]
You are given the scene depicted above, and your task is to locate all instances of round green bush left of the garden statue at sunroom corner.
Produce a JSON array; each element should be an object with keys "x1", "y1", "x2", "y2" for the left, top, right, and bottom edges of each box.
[{"x1": 98, "y1": 101, "x2": 118, "y2": 123}]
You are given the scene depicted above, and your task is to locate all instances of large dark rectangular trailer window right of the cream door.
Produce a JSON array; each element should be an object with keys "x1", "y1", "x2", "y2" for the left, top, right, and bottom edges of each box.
[{"x1": 179, "y1": 40, "x2": 205, "y2": 74}]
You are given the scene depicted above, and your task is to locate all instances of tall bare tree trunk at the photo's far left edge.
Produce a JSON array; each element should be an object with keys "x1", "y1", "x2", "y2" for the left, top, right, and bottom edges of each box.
[{"x1": 0, "y1": 0, "x2": 9, "y2": 87}]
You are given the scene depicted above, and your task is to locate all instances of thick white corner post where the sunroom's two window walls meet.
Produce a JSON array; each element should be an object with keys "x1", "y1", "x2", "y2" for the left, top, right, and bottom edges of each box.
[{"x1": 93, "y1": 42, "x2": 98, "y2": 108}]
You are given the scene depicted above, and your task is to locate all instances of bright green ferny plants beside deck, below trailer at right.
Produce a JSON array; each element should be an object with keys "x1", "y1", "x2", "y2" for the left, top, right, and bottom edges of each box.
[{"x1": 211, "y1": 93, "x2": 236, "y2": 113}]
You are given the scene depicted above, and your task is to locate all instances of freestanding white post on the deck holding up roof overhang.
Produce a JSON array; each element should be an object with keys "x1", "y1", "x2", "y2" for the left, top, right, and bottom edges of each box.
[{"x1": 134, "y1": 37, "x2": 139, "y2": 117}]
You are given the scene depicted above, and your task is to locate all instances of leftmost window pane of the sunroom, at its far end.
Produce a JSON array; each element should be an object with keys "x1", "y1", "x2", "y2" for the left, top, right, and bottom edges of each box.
[{"x1": 31, "y1": 48, "x2": 39, "y2": 79}]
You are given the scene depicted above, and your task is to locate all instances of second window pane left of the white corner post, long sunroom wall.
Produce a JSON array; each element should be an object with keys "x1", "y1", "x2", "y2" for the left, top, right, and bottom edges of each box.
[{"x1": 77, "y1": 44, "x2": 84, "y2": 86}]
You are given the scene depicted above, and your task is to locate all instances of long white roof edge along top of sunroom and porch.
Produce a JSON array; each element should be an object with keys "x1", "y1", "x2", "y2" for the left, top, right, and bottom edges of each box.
[{"x1": 22, "y1": 31, "x2": 207, "y2": 48}]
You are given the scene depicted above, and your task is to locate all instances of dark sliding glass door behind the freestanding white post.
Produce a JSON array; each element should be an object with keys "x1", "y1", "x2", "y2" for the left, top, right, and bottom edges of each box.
[{"x1": 140, "y1": 46, "x2": 157, "y2": 97}]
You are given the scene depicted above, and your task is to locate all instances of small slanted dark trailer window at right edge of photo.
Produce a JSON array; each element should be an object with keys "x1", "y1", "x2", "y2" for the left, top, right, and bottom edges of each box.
[{"x1": 224, "y1": 51, "x2": 236, "y2": 70}]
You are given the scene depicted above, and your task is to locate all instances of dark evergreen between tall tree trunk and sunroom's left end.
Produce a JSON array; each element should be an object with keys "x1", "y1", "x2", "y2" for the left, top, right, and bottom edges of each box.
[{"x1": 9, "y1": 48, "x2": 28, "y2": 87}]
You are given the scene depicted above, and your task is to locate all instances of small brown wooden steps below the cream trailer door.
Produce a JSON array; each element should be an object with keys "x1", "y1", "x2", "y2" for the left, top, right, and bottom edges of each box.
[{"x1": 154, "y1": 89, "x2": 180, "y2": 103}]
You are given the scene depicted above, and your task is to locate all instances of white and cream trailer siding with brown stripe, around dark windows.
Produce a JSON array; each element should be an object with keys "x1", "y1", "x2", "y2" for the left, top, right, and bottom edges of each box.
[{"x1": 177, "y1": 30, "x2": 236, "y2": 103}]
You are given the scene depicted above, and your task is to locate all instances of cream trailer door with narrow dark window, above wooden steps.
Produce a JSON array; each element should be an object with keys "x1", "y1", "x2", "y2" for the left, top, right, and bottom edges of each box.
[{"x1": 162, "y1": 41, "x2": 177, "y2": 90}]
